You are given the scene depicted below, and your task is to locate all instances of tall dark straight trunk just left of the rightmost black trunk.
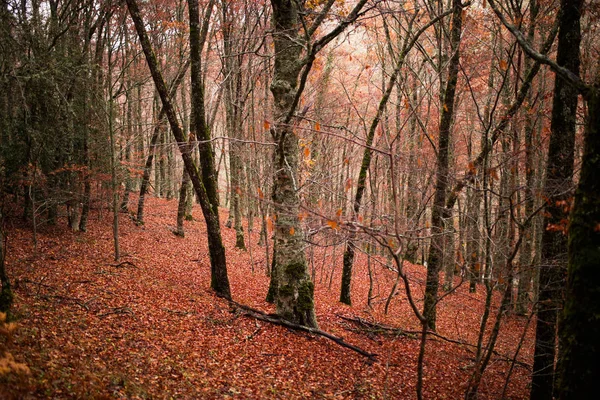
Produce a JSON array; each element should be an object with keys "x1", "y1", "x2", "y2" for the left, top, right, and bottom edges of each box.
[{"x1": 531, "y1": 0, "x2": 582, "y2": 400}]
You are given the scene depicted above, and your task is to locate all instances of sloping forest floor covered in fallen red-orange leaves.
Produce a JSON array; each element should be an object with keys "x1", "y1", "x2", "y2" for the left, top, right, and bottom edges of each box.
[{"x1": 0, "y1": 198, "x2": 534, "y2": 399}]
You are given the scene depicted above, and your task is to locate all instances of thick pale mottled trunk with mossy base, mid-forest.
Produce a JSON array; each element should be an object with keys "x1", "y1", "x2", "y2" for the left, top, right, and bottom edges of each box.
[{"x1": 271, "y1": 0, "x2": 317, "y2": 327}]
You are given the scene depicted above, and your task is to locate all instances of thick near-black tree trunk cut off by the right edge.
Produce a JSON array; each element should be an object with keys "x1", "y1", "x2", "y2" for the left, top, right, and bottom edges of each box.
[{"x1": 557, "y1": 82, "x2": 600, "y2": 400}]
